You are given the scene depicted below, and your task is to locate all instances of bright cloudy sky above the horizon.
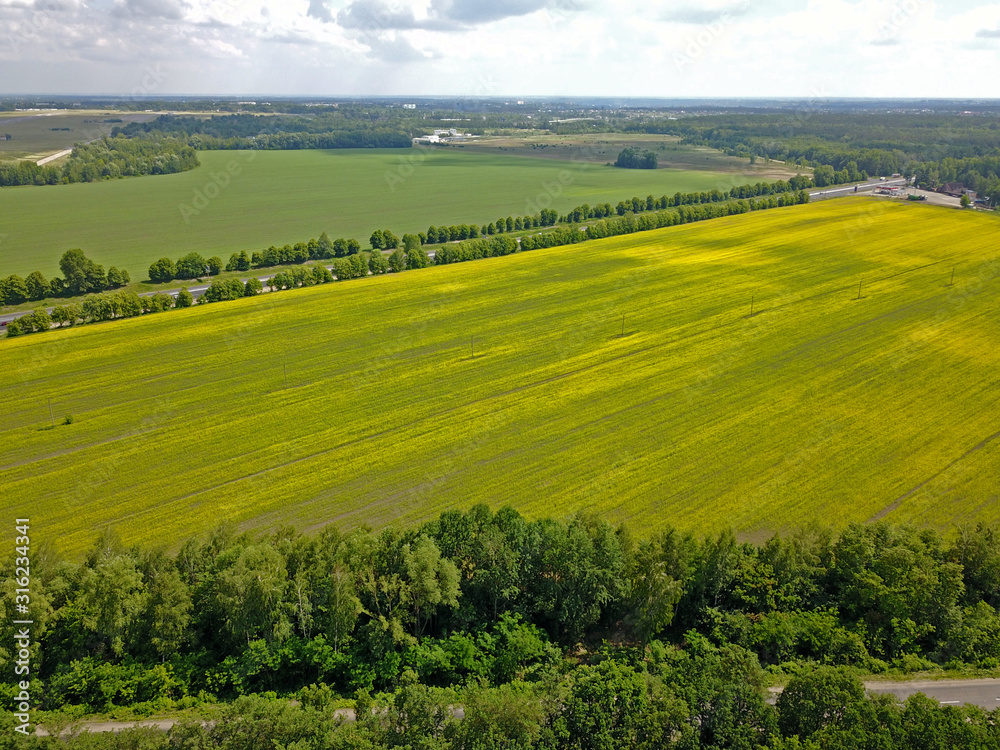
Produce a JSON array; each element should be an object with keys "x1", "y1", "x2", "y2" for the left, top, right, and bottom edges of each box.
[{"x1": 0, "y1": 0, "x2": 1000, "y2": 98}]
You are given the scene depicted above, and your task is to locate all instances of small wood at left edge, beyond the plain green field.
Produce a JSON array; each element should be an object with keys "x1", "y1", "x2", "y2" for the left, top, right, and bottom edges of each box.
[{"x1": 0, "y1": 137, "x2": 199, "y2": 187}]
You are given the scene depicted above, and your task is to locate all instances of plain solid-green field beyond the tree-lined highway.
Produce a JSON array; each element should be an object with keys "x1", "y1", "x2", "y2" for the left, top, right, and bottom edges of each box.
[{"x1": 0, "y1": 147, "x2": 756, "y2": 280}]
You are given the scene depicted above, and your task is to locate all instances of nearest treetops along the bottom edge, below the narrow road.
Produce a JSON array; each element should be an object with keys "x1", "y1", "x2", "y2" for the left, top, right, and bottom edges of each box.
[{"x1": 7, "y1": 668, "x2": 1000, "y2": 750}]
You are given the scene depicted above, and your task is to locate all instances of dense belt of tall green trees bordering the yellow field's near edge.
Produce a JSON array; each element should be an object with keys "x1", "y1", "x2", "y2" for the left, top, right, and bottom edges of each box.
[{"x1": 0, "y1": 506, "x2": 1000, "y2": 748}]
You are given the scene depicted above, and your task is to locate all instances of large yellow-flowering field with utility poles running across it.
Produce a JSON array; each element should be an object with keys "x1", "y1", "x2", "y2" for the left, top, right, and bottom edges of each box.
[{"x1": 0, "y1": 199, "x2": 1000, "y2": 553}]
